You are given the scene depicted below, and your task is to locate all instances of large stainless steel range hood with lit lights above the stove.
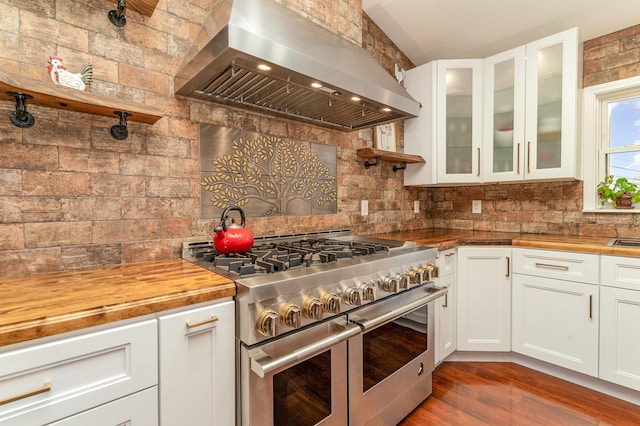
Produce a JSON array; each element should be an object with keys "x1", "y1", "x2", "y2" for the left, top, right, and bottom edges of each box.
[{"x1": 175, "y1": 0, "x2": 420, "y2": 131}]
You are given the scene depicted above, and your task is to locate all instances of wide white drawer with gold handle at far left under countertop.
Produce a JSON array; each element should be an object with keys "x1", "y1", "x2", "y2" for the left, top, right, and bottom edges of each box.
[{"x1": 0, "y1": 319, "x2": 158, "y2": 425}]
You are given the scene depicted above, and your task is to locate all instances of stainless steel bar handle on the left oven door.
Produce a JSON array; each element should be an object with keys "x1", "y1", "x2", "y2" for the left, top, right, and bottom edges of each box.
[{"x1": 249, "y1": 324, "x2": 361, "y2": 378}]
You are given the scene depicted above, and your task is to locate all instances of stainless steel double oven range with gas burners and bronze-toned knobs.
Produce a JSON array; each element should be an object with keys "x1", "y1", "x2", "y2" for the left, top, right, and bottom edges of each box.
[{"x1": 183, "y1": 231, "x2": 447, "y2": 426}]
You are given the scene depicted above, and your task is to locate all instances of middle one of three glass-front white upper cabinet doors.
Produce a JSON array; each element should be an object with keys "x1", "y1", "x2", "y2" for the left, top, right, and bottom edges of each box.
[{"x1": 482, "y1": 46, "x2": 526, "y2": 182}]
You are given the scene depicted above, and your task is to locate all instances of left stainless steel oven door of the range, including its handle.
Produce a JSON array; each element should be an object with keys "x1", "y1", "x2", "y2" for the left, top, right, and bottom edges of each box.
[{"x1": 240, "y1": 316, "x2": 360, "y2": 426}]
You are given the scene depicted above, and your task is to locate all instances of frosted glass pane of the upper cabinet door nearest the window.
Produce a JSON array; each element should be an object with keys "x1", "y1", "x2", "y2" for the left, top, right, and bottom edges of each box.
[{"x1": 536, "y1": 44, "x2": 563, "y2": 169}]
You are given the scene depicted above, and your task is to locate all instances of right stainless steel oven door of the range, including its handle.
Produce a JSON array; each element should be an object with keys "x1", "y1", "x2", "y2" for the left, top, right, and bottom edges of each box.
[{"x1": 348, "y1": 286, "x2": 447, "y2": 426}]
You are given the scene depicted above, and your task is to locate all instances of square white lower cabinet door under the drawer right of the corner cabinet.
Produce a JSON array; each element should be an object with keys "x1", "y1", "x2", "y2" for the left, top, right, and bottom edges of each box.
[{"x1": 512, "y1": 274, "x2": 599, "y2": 377}]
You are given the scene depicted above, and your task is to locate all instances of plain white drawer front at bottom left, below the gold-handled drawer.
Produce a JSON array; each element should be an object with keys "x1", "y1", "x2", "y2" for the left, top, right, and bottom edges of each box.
[{"x1": 50, "y1": 386, "x2": 158, "y2": 426}]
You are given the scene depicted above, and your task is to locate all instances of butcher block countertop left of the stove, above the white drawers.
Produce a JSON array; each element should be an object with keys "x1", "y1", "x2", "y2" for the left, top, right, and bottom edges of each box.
[{"x1": 0, "y1": 259, "x2": 236, "y2": 346}]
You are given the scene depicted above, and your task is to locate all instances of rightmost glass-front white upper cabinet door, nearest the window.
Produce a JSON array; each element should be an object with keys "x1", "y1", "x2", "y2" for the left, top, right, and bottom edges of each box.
[{"x1": 525, "y1": 28, "x2": 578, "y2": 179}]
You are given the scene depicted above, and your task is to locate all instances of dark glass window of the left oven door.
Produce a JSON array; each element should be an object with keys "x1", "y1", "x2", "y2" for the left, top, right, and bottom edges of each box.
[{"x1": 273, "y1": 351, "x2": 331, "y2": 426}]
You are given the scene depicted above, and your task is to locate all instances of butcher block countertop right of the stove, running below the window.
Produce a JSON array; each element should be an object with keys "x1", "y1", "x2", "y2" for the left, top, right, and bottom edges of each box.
[{"x1": 375, "y1": 229, "x2": 640, "y2": 257}]
